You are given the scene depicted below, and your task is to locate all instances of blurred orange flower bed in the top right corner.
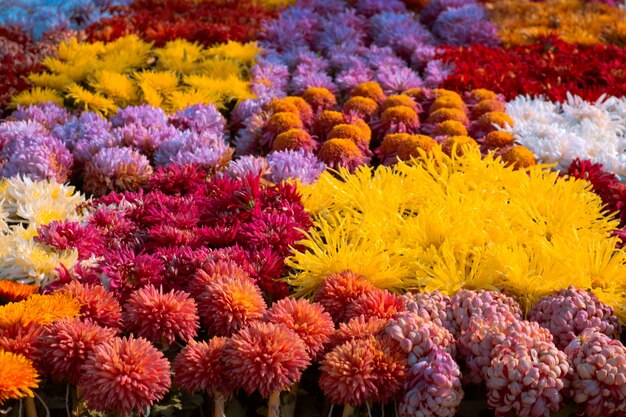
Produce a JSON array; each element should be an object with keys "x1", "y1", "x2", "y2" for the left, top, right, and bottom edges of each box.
[{"x1": 486, "y1": 0, "x2": 626, "y2": 47}]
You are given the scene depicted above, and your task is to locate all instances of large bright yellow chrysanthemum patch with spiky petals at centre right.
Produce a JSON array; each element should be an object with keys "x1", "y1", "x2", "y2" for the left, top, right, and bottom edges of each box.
[{"x1": 287, "y1": 148, "x2": 626, "y2": 322}]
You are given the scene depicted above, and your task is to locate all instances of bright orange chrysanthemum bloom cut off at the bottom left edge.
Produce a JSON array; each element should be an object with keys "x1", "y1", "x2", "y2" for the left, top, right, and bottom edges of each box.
[{"x1": 0, "y1": 350, "x2": 39, "y2": 404}]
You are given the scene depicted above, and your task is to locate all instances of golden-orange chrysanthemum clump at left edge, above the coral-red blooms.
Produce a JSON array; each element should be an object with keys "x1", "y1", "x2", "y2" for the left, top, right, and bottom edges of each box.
[{"x1": 0, "y1": 292, "x2": 80, "y2": 329}]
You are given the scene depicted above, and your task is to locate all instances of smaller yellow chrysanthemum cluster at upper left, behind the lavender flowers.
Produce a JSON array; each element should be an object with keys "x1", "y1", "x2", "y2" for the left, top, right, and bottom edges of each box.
[{"x1": 11, "y1": 35, "x2": 258, "y2": 115}]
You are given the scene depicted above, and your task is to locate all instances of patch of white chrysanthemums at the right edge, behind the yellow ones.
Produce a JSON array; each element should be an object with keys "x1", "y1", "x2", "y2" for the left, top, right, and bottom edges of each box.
[{"x1": 506, "y1": 94, "x2": 626, "y2": 179}]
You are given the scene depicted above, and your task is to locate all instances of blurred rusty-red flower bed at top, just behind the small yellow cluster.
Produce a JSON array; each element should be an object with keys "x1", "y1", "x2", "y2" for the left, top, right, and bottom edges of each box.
[{"x1": 85, "y1": 0, "x2": 274, "y2": 46}]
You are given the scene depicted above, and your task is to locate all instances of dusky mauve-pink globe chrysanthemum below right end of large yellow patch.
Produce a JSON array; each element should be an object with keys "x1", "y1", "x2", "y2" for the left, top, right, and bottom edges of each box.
[{"x1": 528, "y1": 287, "x2": 621, "y2": 349}]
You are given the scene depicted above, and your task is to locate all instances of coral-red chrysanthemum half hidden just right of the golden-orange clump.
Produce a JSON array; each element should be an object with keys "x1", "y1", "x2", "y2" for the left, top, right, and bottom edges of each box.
[{"x1": 60, "y1": 281, "x2": 122, "y2": 329}]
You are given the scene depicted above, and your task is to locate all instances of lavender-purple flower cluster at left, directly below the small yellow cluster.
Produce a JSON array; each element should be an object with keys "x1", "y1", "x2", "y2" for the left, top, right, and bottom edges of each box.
[{"x1": 0, "y1": 103, "x2": 232, "y2": 196}]
